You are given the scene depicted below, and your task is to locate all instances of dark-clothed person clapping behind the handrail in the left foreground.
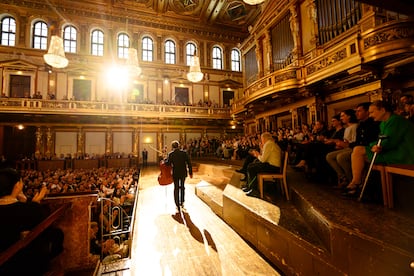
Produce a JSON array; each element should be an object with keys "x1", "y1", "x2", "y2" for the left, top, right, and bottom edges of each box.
[{"x1": 0, "y1": 169, "x2": 63, "y2": 275}]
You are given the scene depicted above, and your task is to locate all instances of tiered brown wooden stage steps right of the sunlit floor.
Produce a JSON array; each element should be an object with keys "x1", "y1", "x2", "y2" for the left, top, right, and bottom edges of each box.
[{"x1": 196, "y1": 163, "x2": 414, "y2": 275}]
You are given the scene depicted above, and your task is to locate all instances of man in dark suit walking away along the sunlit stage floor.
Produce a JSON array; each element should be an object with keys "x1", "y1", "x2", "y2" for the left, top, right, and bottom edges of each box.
[{"x1": 165, "y1": 141, "x2": 193, "y2": 210}]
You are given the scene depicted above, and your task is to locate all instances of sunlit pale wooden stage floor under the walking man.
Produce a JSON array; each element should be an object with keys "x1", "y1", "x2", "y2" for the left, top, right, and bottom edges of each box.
[{"x1": 131, "y1": 166, "x2": 279, "y2": 276}]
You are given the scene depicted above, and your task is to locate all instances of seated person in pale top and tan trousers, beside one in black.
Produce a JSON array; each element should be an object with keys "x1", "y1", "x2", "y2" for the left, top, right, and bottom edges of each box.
[{"x1": 326, "y1": 109, "x2": 358, "y2": 188}]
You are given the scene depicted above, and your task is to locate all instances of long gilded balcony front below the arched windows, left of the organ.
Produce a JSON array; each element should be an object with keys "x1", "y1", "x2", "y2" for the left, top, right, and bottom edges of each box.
[{"x1": 0, "y1": 98, "x2": 230, "y2": 119}]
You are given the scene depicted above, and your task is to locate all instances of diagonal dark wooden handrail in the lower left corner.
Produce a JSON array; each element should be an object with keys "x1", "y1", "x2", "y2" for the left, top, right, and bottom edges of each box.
[{"x1": 0, "y1": 202, "x2": 71, "y2": 266}]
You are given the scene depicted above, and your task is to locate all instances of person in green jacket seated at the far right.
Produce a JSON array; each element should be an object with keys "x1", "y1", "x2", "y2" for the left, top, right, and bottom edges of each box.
[{"x1": 346, "y1": 101, "x2": 414, "y2": 195}]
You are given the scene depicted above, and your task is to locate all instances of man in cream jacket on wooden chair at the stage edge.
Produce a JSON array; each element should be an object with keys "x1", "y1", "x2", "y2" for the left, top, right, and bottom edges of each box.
[{"x1": 243, "y1": 132, "x2": 282, "y2": 196}]
